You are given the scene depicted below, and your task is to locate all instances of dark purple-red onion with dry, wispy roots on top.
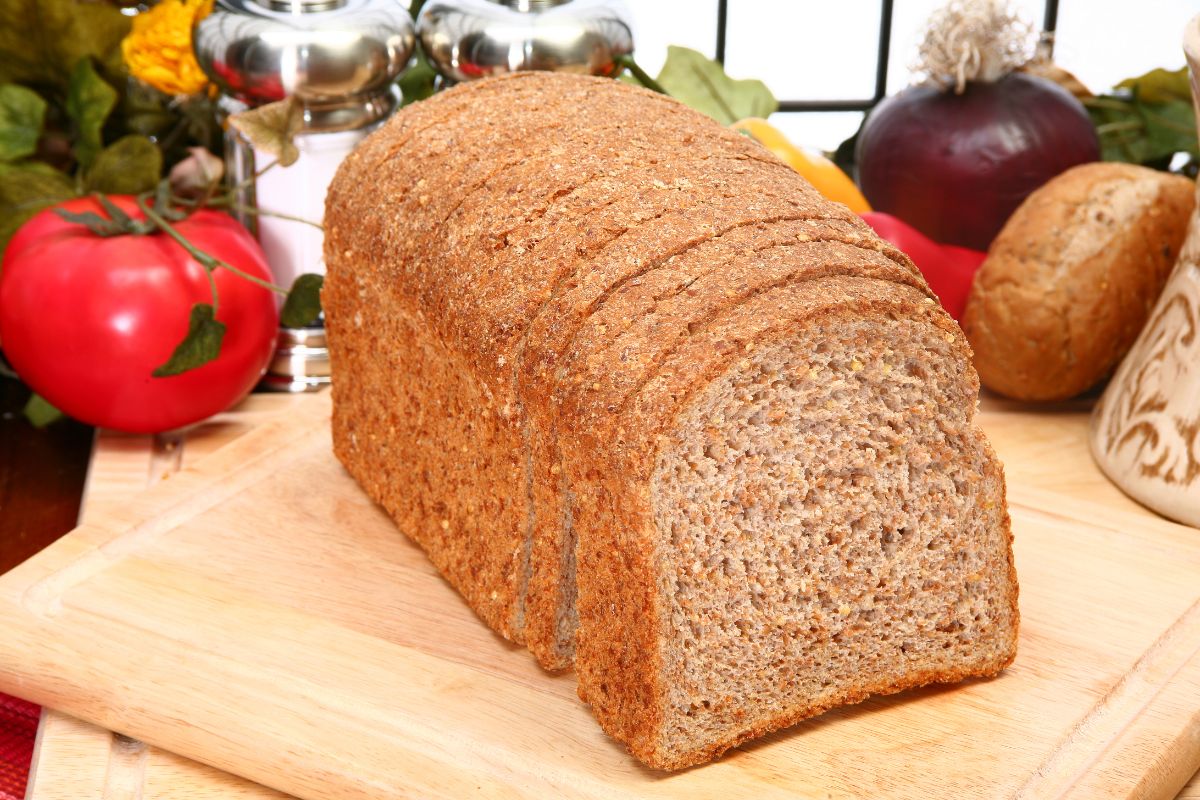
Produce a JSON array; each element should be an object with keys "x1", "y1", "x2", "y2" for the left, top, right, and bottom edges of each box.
[{"x1": 857, "y1": 0, "x2": 1100, "y2": 249}]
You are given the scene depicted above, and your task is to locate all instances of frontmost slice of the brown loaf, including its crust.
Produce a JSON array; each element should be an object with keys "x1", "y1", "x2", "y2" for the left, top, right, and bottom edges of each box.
[{"x1": 563, "y1": 277, "x2": 1018, "y2": 769}]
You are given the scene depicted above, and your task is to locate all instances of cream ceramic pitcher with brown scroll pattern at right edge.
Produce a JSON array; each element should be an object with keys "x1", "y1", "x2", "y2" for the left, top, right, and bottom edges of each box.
[{"x1": 1091, "y1": 16, "x2": 1200, "y2": 527}]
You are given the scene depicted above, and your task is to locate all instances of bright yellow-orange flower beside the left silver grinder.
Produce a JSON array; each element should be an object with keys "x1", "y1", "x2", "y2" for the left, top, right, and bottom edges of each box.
[{"x1": 121, "y1": 0, "x2": 212, "y2": 95}]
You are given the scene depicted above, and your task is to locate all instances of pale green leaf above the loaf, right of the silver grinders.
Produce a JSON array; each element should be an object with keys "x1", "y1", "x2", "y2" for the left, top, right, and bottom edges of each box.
[{"x1": 658, "y1": 44, "x2": 779, "y2": 125}]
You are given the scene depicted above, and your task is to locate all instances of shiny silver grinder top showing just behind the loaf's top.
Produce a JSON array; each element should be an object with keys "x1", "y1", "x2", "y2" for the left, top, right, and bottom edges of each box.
[{"x1": 416, "y1": 0, "x2": 634, "y2": 83}]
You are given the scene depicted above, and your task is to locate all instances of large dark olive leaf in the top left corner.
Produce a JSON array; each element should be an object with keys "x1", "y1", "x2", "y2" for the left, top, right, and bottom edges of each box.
[{"x1": 0, "y1": 0, "x2": 130, "y2": 92}]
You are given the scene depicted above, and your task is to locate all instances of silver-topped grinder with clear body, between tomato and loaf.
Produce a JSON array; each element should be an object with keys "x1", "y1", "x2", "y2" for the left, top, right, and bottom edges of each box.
[{"x1": 193, "y1": 0, "x2": 415, "y2": 391}]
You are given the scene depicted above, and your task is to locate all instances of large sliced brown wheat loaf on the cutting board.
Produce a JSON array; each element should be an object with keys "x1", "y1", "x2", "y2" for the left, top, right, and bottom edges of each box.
[{"x1": 323, "y1": 73, "x2": 1018, "y2": 769}]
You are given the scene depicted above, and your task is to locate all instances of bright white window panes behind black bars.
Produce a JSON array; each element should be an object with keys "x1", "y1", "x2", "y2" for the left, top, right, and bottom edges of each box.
[{"x1": 626, "y1": 0, "x2": 1200, "y2": 150}]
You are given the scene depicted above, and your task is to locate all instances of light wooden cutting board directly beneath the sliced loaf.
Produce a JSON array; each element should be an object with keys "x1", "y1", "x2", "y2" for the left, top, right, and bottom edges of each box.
[{"x1": 0, "y1": 391, "x2": 1200, "y2": 798}]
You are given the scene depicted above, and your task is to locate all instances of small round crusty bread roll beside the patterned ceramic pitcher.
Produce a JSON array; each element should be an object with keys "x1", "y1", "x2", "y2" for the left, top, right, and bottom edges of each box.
[{"x1": 962, "y1": 163, "x2": 1195, "y2": 401}]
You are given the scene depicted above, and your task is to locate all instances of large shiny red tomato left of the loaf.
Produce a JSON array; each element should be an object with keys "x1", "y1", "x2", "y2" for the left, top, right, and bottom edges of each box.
[{"x1": 0, "y1": 197, "x2": 278, "y2": 433}]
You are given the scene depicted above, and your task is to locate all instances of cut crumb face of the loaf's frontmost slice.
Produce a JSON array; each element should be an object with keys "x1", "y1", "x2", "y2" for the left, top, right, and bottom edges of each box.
[{"x1": 601, "y1": 318, "x2": 1018, "y2": 769}]
